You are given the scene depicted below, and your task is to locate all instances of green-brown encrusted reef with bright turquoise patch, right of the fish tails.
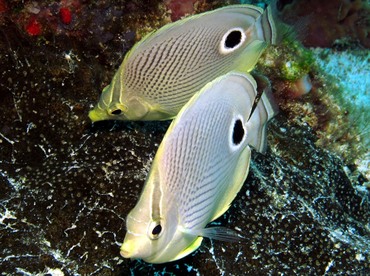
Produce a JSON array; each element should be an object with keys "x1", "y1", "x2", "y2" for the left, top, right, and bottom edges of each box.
[{"x1": 256, "y1": 33, "x2": 370, "y2": 171}]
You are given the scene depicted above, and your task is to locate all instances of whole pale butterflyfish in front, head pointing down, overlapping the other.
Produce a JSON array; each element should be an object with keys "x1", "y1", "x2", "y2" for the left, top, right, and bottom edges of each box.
[{"x1": 121, "y1": 72, "x2": 275, "y2": 263}]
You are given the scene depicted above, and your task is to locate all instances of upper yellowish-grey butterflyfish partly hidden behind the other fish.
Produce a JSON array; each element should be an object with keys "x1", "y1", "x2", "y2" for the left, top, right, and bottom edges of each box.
[{"x1": 89, "y1": 5, "x2": 276, "y2": 122}]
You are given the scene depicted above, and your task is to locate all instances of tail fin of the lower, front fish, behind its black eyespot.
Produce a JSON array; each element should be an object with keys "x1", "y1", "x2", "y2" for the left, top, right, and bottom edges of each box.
[{"x1": 247, "y1": 74, "x2": 278, "y2": 153}]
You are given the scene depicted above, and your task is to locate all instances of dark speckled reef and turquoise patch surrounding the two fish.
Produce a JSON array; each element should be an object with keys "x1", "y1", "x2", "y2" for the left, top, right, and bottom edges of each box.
[{"x1": 0, "y1": 0, "x2": 370, "y2": 275}]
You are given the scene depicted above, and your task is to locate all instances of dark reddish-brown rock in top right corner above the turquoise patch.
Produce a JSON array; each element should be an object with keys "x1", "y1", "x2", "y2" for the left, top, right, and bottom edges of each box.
[{"x1": 276, "y1": 0, "x2": 370, "y2": 48}]
